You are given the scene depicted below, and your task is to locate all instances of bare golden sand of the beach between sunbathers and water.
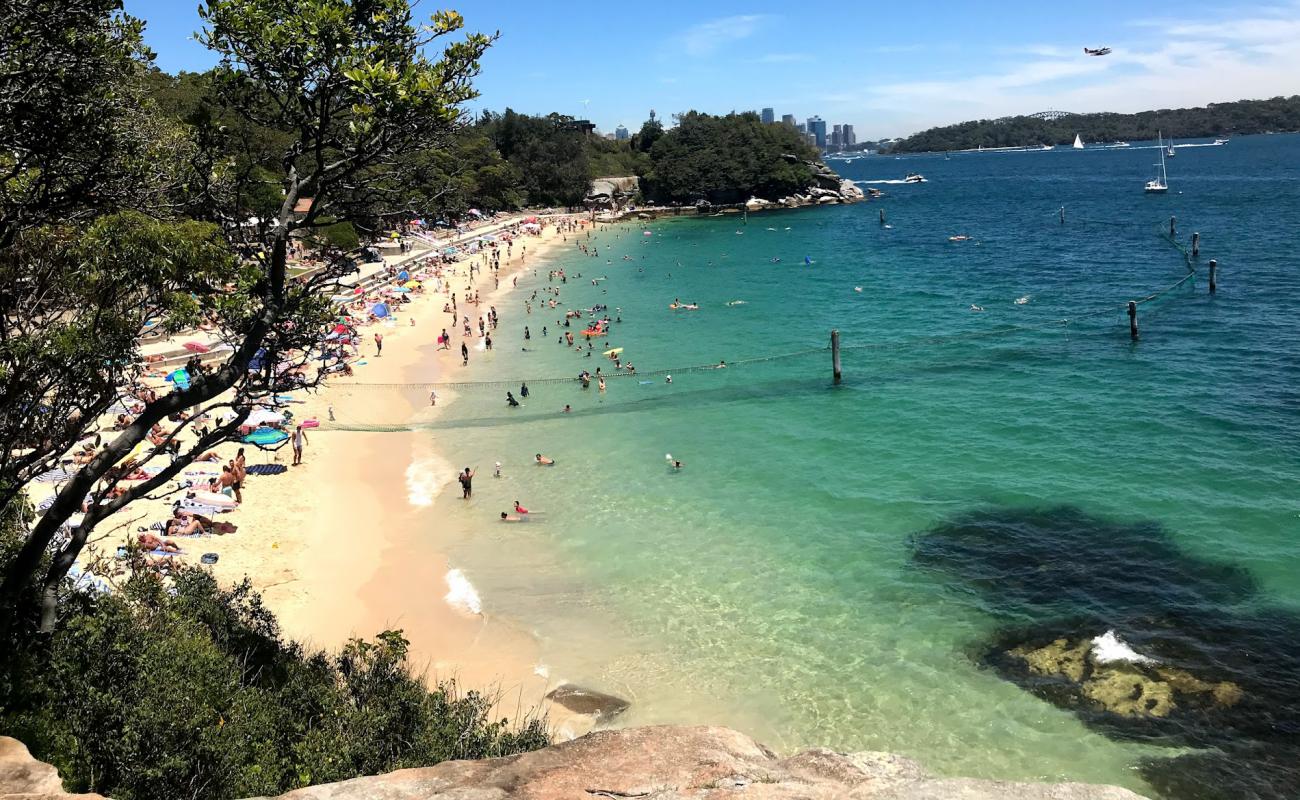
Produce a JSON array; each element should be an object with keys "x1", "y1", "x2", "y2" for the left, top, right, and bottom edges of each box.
[{"x1": 83, "y1": 217, "x2": 582, "y2": 721}]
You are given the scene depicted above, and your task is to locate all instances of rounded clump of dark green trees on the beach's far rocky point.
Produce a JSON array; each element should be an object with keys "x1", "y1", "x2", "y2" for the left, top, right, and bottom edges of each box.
[{"x1": 645, "y1": 112, "x2": 818, "y2": 203}]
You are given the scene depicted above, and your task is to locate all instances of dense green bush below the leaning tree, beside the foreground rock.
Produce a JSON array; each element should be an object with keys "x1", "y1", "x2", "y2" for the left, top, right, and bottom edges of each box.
[{"x1": 0, "y1": 520, "x2": 550, "y2": 800}]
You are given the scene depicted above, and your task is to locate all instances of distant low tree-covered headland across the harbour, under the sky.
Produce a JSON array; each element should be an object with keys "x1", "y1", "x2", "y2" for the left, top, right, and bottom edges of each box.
[{"x1": 889, "y1": 95, "x2": 1300, "y2": 152}]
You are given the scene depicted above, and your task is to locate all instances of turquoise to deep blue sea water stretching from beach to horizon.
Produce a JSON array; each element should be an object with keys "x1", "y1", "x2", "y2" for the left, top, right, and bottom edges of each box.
[{"x1": 340, "y1": 135, "x2": 1300, "y2": 797}]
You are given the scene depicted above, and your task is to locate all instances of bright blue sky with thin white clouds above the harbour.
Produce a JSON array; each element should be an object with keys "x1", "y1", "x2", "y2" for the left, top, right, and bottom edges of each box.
[{"x1": 125, "y1": 0, "x2": 1300, "y2": 139}]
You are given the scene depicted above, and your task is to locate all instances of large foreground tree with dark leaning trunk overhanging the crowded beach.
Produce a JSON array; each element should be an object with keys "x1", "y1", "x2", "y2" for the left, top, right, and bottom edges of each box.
[{"x1": 0, "y1": 0, "x2": 493, "y2": 630}]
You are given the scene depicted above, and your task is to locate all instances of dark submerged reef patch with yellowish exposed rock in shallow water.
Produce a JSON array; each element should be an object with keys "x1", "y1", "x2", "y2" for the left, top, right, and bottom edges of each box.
[{"x1": 914, "y1": 506, "x2": 1300, "y2": 800}]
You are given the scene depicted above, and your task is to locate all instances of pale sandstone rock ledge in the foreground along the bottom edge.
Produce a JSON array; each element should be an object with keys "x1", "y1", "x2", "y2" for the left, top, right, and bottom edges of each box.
[{"x1": 0, "y1": 726, "x2": 1141, "y2": 800}]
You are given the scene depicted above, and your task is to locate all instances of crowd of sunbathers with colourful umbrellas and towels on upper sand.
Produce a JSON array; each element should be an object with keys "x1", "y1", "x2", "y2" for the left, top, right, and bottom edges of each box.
[{"x1": 30, "y1": 215, "x2": 589, "y2": 591}]
